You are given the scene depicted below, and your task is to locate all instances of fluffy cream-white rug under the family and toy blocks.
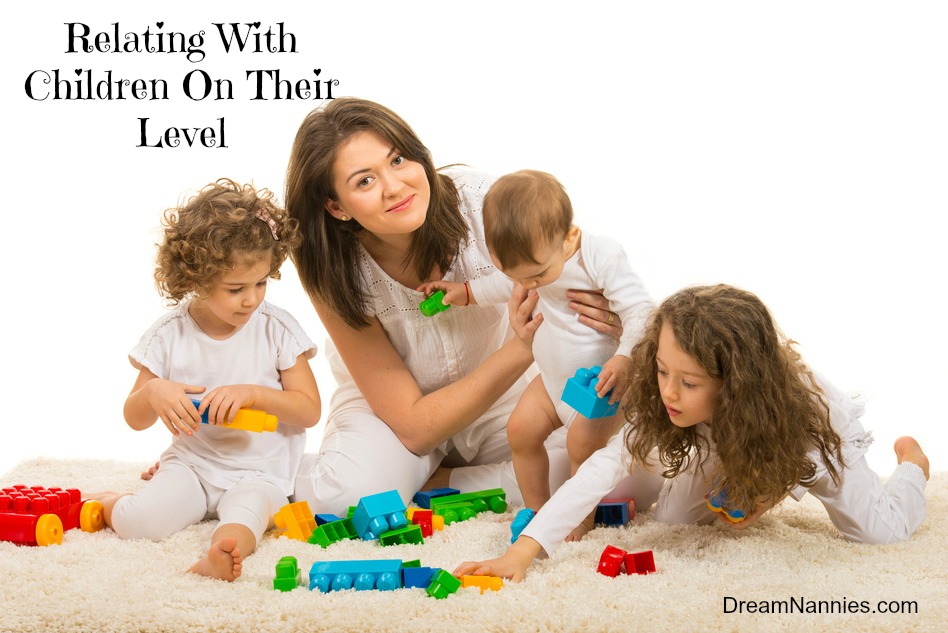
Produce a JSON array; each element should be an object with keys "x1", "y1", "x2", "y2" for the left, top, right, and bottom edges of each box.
[{"x1": 0, "y1": 460, "x2": 948, "y2": 633}]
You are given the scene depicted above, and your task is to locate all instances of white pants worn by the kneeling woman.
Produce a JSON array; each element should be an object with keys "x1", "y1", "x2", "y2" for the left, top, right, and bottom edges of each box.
[{"x1": 292, "y1": 400, "x2": 569, "y2": 516}]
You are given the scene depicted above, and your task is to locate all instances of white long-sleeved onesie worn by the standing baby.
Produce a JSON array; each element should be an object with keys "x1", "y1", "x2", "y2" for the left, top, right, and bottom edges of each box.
[{"x1": 472, "y1": 234, "x2": 654, "y2": 425}]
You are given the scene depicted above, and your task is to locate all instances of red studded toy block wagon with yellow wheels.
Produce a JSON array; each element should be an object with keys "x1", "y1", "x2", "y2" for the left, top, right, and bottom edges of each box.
[{"x1": 0, "y1": 484, "x2": 105, "y2": 545}]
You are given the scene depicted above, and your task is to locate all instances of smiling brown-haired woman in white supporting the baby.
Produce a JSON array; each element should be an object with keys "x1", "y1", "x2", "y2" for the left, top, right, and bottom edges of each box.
[{"x1": 286, "y1": 98, "x2": 620, "y2": 513}]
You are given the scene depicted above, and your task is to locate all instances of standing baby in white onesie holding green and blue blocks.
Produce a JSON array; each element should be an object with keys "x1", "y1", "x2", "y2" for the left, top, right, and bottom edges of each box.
[{"x1": 422, "y1": 170, "x2": 653, "y2": 540}]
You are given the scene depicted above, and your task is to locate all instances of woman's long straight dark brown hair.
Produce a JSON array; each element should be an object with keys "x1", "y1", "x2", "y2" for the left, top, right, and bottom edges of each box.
[{"x1": 286, "y1": 97, "x2": 468, "y2": 328}]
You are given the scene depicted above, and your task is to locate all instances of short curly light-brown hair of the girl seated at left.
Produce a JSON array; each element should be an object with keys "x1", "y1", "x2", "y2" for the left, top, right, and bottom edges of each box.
[{"x1": 155, "y1": 178, "x2": 299, "y2": 305}]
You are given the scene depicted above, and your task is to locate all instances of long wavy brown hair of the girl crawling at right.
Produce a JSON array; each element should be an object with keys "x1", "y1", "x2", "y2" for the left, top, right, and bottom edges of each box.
[{"x1": 625, "y1": 285, "x2": 843, "y2": 508}]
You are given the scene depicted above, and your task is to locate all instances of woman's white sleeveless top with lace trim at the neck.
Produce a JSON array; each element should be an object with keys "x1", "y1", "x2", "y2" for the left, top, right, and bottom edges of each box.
[{"x1": 326, "y1": 167, "x2": 529, "y2": 461}]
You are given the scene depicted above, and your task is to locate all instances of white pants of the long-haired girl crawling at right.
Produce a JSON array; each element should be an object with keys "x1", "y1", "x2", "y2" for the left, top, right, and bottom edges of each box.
[{"x1": 655, "y1": 456, "x2": 926, "y2": 544}]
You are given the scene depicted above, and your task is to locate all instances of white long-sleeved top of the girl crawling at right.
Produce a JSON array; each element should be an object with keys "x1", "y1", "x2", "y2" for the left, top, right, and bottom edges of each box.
[{"x1": 523, "y1": 376, "x2": 872, "y2": 555}]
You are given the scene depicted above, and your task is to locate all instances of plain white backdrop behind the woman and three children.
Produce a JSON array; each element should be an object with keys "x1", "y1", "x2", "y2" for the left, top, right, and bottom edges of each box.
[{"x1": 0, "y1": 0, "x2": 948, "y2": 483}]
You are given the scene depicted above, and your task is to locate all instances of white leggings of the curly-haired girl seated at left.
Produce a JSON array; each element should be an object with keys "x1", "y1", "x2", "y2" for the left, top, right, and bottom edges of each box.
[{"x1": 112, "y1": 459, "x2": 288, "y2": 542}]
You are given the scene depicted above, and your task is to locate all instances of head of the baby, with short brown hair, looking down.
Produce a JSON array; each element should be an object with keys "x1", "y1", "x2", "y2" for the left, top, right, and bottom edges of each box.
[{"x1": 484, "y1": 169, "x2": 580, "y2": 288}]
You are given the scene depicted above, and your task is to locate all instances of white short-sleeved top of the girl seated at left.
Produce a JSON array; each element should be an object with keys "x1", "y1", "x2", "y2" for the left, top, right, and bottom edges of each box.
[{"x1": 129, "y1": 301, "x2": 316, "y2": 495}]
